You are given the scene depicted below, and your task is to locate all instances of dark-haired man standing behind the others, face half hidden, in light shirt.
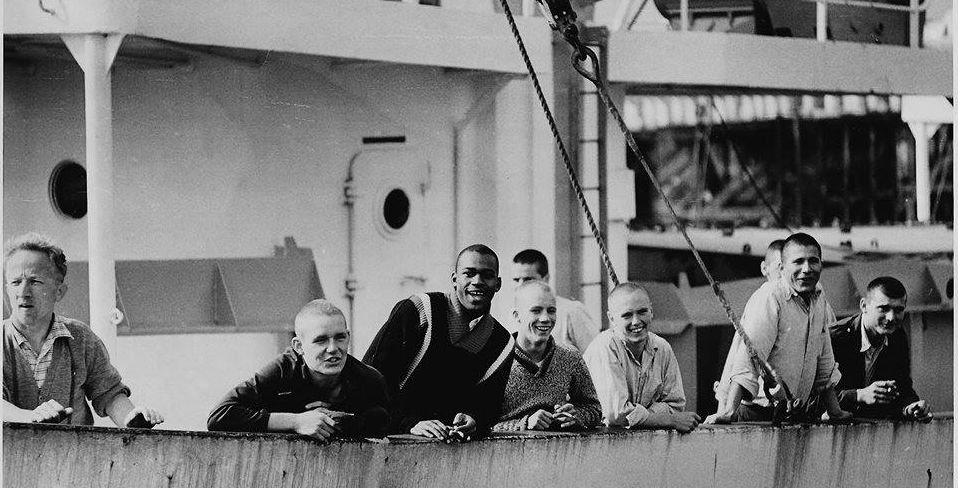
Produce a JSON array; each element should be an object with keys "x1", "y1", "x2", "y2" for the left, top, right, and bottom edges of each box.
[{"x1": 512, "y1": 249, "x2": 599, "y2": 354}]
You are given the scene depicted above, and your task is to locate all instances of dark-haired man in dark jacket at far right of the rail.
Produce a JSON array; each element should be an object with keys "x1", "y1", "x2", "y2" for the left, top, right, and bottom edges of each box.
[{"x1": 830, "y1": 276, "x2": 931, "y2": 420}]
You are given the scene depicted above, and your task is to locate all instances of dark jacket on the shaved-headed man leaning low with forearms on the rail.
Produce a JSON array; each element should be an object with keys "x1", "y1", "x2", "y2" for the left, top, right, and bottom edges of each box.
[{"x1": 206, "y1": 348, "x2": 389, "y2": 437}]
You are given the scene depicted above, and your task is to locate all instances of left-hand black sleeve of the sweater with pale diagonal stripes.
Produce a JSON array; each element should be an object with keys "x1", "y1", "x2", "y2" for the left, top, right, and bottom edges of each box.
[{"x1": 363, "y1": 299, "x2": 423, "y2": 434}]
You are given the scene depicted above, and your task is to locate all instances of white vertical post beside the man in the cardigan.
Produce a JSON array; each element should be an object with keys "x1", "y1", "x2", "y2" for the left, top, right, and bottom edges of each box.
[{"x1": 81, "y1": 34, "x2": 116, "y2": 356}]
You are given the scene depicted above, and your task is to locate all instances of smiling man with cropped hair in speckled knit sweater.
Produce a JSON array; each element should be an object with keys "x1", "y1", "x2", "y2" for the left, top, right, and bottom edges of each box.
[{"x1": 495, "y1": 281, "x2": 602, "y2": 431}]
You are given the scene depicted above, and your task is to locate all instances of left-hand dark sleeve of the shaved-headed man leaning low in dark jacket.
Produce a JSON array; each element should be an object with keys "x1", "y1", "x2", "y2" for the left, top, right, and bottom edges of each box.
[{"x1": 206, "y1": 359, "x2": 284, "y2": 432}]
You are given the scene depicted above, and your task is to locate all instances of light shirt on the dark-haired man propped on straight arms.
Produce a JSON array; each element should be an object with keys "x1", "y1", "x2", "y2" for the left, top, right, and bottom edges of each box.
[{"x1": 729, "y1": 278, "x2": 841, "y2": 405}]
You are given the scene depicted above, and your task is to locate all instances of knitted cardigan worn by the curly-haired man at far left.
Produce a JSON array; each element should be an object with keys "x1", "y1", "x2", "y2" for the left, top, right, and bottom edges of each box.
[{"x1": 3, "y1": 315, "x2": 130, "y2": 425}]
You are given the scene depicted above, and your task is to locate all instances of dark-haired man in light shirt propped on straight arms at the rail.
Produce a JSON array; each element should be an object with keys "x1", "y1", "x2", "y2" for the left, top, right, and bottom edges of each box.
[{"x1": 705, "y1": 233, "x2": 850, "y2": 423}]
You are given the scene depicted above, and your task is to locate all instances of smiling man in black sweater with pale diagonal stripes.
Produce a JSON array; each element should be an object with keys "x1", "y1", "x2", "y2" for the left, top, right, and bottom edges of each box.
[{"x1": 363, "y1": 244, "x2": 515, "y2": 440}]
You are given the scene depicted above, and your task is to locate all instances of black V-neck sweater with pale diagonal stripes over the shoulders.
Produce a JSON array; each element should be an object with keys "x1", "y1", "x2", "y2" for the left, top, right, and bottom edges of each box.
[{"x1": 363, "y1": 293, "x2": 514, "y2": 435}]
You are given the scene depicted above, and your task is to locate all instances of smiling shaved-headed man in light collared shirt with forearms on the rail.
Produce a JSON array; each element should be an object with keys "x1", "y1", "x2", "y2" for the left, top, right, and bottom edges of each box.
[{"x1": 584, "y1": 283, "x2": 701, "y2": 432}]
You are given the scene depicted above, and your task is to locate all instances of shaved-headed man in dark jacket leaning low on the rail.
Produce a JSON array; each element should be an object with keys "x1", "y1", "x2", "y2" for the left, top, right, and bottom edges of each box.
[{"x1": 207, "y1": 300, "x2": 389, "y2": 441}]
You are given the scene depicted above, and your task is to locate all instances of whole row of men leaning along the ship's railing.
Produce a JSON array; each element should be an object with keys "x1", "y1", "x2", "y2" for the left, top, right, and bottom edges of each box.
[{"x1": 3, "y1": 233, "x2": 931, "y2": 441}]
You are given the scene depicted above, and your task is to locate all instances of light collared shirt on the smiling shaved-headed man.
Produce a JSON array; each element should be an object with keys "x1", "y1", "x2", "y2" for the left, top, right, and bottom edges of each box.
[{"x1": 583, "y1": 329, "x2": 685, "y2": 427}]
